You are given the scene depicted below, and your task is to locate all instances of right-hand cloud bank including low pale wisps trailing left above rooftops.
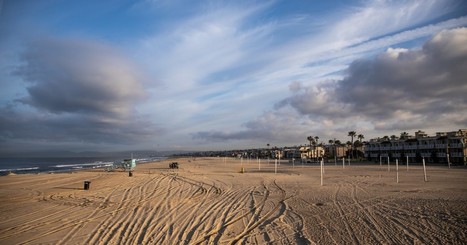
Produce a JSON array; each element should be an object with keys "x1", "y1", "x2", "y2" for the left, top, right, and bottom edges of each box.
[{"x1": 195, "y1": 28, "x2": 467, "y2": 140}]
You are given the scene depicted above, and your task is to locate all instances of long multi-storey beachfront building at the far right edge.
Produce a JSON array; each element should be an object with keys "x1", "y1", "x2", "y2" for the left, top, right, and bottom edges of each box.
[{"x1": 365, "y1": 129, "x2": 467, "y2": 165}]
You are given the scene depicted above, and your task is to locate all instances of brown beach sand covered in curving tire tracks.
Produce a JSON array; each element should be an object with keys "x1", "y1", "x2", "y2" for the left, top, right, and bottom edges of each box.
[{"x1": 0, "y1": 158, "x2": 467, "y2": 244}]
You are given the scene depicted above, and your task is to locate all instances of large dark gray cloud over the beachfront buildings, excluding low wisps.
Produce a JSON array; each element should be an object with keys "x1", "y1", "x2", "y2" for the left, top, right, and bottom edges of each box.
[{"x1": 277, "y1": 28, "x2": 467, "y2": 126}]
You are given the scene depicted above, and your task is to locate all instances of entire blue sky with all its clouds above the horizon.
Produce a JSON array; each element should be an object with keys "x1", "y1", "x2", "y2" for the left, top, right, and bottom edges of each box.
[{"x1": 0, "y1": 0, "x2": 467, "y2": 154}]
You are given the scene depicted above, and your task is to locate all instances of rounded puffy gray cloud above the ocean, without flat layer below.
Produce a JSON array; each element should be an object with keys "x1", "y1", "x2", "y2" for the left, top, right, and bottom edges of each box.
[{"x1": 16, "y1": 38, "x2": 145, "y2": 117}]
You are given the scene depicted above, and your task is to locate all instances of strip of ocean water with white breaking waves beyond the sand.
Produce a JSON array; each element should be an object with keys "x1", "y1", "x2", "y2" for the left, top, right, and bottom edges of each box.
[{"x1": 0, "y1": 157, "x2": 166, "y2": 176}]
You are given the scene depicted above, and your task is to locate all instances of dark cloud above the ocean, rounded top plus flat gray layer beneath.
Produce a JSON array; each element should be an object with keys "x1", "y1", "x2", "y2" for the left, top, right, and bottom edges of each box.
[{"x1": 0, "y1": 38, "x2": 162, "y2": 153}]
